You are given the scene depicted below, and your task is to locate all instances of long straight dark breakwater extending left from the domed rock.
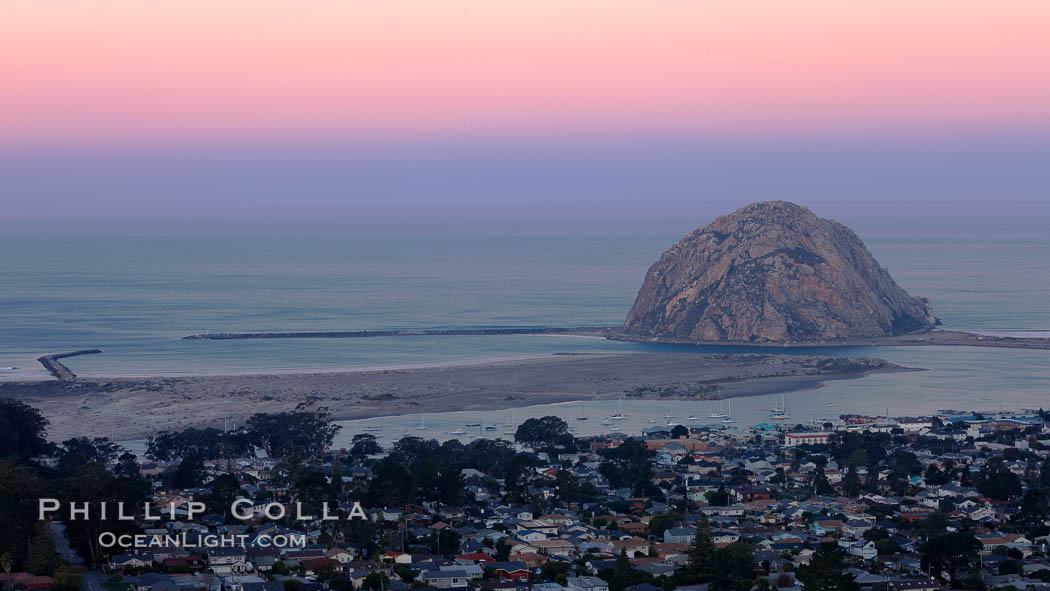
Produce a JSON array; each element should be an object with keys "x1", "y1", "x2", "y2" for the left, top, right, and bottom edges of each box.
[{"x1": 183, "y1": 326, "x2": 618, "y2": 340}]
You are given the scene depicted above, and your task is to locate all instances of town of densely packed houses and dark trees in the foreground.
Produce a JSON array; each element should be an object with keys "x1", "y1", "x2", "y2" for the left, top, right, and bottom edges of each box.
[{"x1": 6, "y1": 399, "x2": 1050, "y2": 591}]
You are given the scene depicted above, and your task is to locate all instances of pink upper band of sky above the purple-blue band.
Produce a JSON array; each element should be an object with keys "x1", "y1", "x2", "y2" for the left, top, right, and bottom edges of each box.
[{"x1": 0, "y1": 0, "x2": 1050, "y2": 147}]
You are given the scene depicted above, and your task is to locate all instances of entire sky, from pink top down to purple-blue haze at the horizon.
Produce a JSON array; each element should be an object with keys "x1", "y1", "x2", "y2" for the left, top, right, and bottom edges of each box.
[{"x1": 0, "y1": 0, "x2": 1050, "y2": 234}]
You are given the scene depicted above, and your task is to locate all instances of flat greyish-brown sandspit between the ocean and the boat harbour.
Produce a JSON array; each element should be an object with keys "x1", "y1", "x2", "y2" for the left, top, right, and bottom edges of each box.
[{"x1": 0, "y1": 354, "x2": 905, "y2": 441}]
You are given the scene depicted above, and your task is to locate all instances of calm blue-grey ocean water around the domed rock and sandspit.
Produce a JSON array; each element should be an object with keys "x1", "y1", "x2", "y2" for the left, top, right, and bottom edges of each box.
[{"x1": 0, "y1": 227, "x2": 1050, "y2": 430}]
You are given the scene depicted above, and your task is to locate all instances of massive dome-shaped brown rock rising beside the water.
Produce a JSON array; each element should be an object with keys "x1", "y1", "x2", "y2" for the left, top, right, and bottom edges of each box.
[{"x1": 624, "y1": 202, "x2": 936, "y2": 342}]
